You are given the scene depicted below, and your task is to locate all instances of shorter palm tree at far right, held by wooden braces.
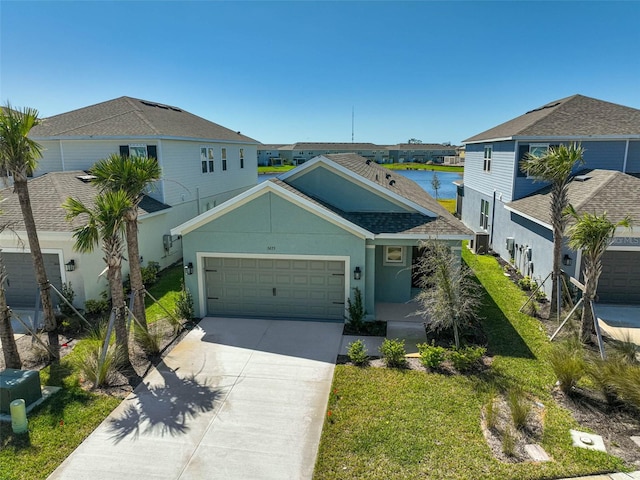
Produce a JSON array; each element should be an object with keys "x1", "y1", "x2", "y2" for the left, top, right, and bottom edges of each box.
[{"x1": 567, "y1": 205, "x2": 631, "y2": 343}]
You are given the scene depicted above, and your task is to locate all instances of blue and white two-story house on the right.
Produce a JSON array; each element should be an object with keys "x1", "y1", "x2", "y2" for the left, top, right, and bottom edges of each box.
[{"x1": 457, "y1": 95, "x2": 640, "y2": 298}]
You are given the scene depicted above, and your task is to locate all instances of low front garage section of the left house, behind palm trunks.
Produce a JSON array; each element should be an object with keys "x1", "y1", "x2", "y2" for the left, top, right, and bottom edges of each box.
[{"x1": 0, "y1": 170, "x2": 171, "y2": 308}]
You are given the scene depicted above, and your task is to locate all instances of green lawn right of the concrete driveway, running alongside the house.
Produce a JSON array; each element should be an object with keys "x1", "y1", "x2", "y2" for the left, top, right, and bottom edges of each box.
[{"x1": 314, "y1": 249, "x2": 625, "y2": 479}]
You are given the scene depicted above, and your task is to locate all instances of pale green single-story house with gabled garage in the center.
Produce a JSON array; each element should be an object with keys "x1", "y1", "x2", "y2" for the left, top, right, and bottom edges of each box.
[{"x1": 171, "y1": 154, "x2": 471, "y2": 320}]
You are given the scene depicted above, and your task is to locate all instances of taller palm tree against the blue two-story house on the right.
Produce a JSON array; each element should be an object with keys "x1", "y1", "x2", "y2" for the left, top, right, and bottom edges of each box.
[{"x1": 521, "y1": 142, "x2": 584, "y2": 313}]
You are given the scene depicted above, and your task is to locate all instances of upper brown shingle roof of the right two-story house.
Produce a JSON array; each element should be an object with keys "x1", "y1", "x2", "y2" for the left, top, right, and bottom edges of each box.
[{"x1": 463, "y1": 95, "x2": 640, "y2": 143}]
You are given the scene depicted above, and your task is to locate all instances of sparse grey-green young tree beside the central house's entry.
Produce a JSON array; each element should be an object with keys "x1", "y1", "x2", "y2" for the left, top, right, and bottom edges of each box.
[{"x1": 416, "y1": 240, "x2": 481, "y2": 348}]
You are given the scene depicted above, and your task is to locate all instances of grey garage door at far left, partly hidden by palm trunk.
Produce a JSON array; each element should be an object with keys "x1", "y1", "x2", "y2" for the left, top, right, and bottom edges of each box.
[{"x1": 2, "y1": 252, "x2": 62, "y2": 308}]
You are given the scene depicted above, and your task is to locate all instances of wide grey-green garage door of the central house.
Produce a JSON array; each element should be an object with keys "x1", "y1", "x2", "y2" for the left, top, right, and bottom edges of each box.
[{"x1": 205, "y1": 257, "x2": 345, "y2": 320}]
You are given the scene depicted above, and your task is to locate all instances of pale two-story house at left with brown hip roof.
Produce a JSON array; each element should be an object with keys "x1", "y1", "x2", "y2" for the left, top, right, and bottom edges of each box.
[{"x1": 2, "y1": 97, "x2": 259, "y2": 310}]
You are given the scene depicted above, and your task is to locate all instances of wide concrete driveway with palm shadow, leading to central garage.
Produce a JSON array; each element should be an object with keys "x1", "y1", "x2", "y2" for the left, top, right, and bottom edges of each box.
[{"x1": 49, "y1": 318, "x2": 342, "y2": 480}]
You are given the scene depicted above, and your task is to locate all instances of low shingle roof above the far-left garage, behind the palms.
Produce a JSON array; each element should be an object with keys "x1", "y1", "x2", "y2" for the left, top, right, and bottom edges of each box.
[{"x1": 0, "y1": 170, "x2": 171, "y2": 232}]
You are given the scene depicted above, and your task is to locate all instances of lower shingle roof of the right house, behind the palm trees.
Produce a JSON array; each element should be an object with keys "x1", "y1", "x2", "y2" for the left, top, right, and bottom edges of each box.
[{"x1": 505, "y1": 169, "x2": 640, "y2": 228}]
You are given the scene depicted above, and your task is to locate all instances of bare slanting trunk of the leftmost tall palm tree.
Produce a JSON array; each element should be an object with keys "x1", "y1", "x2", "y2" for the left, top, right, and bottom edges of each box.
[{"x1": 14, "y1": 178, "x2": 60, "y2": 363}]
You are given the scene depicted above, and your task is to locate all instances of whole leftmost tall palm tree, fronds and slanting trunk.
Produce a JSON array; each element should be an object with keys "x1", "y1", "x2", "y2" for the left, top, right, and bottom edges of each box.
[{"x1": 0, "y1": 103, "x2": 60, "y2": 362}]
